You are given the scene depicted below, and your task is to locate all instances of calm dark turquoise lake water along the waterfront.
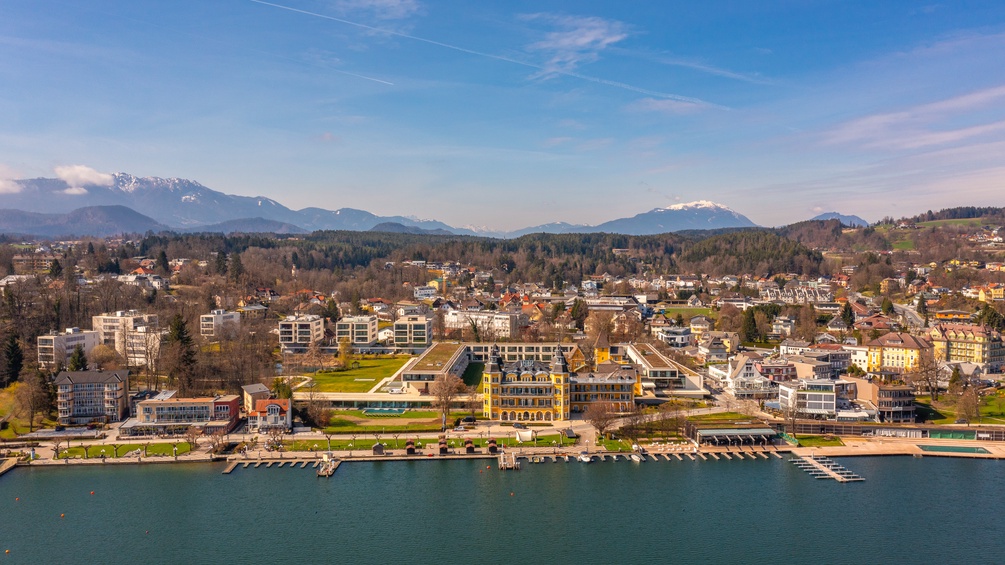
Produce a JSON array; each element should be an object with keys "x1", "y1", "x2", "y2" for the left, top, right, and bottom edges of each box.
[{"x1": 0, "y1": 457, "x2": 1005, "y2": 565}]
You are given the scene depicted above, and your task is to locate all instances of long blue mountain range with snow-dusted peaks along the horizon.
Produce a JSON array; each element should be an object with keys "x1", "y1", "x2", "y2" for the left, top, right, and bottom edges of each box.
[{"x1": 0, "y1": 173, "x2": 756, "y2": 237}]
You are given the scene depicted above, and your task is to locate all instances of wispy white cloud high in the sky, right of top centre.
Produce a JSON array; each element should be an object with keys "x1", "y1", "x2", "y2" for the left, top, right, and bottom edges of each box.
[{"x1": 523, "y1": 14, "x2": 628, "y2": 75}]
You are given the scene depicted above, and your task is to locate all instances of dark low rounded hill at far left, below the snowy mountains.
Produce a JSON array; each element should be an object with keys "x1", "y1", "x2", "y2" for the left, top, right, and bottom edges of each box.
[{"x1": 0, "y1": 206, "x2": 169, "y2": 237}]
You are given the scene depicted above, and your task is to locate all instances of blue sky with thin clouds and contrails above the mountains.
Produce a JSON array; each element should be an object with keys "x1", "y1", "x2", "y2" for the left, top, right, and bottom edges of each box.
[{"x1": 0, "y1": 0, "x2": 1005, "y2": 230}]
